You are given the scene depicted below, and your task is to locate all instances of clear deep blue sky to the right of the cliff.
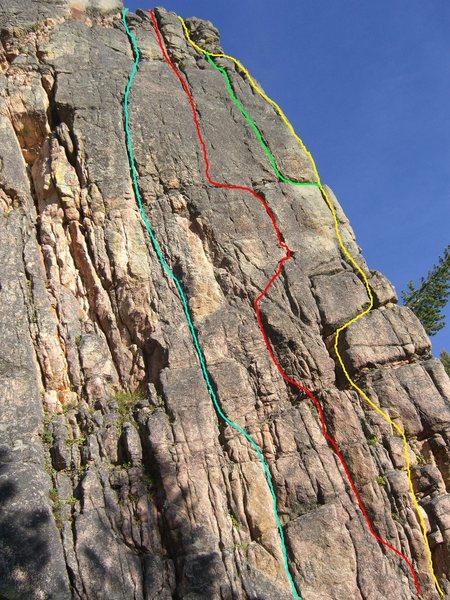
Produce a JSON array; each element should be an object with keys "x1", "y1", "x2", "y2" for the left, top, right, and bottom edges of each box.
[{"x1": 125, "y1": 0, "x2": 450, "y2": 355}]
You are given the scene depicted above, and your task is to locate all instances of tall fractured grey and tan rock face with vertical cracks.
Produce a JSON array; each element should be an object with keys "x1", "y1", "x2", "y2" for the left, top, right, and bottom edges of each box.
[{"x1": 0, "y1": 0, "x2": 450, "y2": 600}]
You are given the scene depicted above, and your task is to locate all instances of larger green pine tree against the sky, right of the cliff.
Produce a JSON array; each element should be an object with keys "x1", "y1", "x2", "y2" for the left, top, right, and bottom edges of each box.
[{"x1": 402, "y1": 246, "x2": 450, "y2": 336}]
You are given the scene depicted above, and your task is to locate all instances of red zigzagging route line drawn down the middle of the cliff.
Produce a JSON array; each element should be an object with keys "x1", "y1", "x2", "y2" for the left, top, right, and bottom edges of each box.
[{"x1": 150, "y1": 10, "x2": 421, "y2": 596}]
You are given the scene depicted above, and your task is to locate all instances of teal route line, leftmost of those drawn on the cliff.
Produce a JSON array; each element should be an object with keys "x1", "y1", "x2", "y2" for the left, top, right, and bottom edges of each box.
[{"x1": 122, "y1": 8, "x2": 302, "y2": 600}]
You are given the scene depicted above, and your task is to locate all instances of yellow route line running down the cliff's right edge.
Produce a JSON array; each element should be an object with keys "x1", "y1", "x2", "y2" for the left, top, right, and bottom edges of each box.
[{"x1": 178, "y1": 16, "x2": 444, "y2": 596}]
